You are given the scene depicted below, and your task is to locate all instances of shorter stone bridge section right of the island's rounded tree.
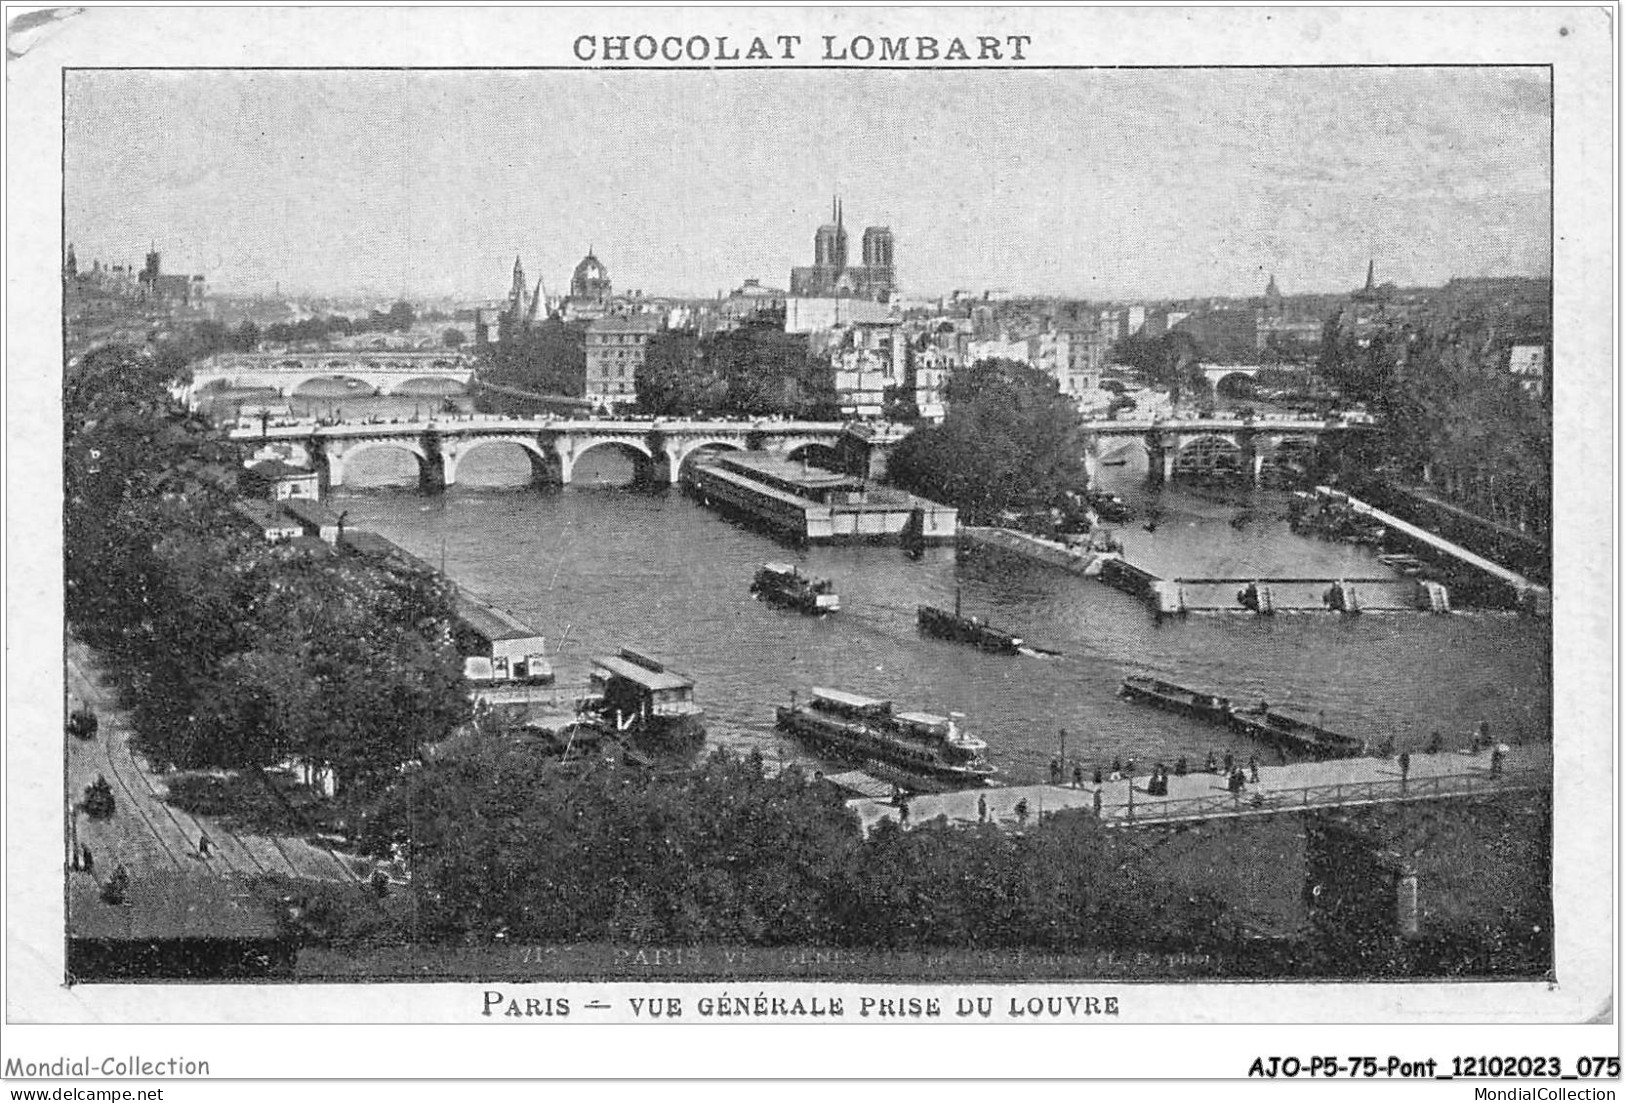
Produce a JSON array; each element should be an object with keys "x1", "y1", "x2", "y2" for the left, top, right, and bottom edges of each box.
[{"x1": 1084, "y1": 416, "x2": 1373, "y2": 482}]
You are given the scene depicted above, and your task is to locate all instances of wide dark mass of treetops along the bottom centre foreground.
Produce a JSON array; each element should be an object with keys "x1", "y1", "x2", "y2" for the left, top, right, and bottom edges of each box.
[{"x1": 352, "y1": 739, "x2": 1222, "y2": 950}]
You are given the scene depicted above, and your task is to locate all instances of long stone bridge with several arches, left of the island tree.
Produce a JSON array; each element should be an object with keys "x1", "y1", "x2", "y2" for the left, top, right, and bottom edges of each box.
[{"x1": 231, "y1": 414, "x2": 874, "y2": 491}]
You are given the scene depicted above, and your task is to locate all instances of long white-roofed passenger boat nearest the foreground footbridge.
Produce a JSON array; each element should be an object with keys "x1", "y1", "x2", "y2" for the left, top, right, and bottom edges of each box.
[{"x1": 778, "y1": 687, "x2": 998, "y2": 788}]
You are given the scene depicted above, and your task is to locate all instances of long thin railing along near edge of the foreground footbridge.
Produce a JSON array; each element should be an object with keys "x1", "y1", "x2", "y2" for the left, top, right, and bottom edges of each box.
[{"x1": 1102, "y1": 770, "x2": 1552, "y2": 827}]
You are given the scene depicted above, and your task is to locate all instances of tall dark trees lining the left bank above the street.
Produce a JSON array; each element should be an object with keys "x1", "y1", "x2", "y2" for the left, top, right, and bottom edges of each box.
[{"x1": 63, "y1": 348, "x2": 468, "y2": 788}]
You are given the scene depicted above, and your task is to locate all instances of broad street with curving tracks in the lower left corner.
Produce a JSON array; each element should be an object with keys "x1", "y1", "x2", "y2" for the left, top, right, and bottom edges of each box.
[{"x1": 65, "y1": 637, "x2": 372, "y2": 980}]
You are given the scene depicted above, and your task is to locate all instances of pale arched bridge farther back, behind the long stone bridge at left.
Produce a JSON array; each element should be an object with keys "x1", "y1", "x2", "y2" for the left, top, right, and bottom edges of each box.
[{"x1": 182, "y1": 349, "x2": 475, "y2": 403}]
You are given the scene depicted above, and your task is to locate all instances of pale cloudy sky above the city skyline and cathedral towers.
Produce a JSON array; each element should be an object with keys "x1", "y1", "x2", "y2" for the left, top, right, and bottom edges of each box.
[{"x1": 63, "y1": 67, "x2": 1552, "y2": 299}]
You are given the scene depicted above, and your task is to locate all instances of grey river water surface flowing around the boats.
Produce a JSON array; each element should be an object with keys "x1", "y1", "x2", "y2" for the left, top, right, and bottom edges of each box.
[{"x1": 216, "y1": 388, "x2": 1552, "y2": 781}]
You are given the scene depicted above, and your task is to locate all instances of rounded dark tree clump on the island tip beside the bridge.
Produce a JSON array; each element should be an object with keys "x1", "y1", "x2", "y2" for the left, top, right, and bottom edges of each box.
[{"x1": 887, "y1": 359, "x2": 1087, "y2": 521}]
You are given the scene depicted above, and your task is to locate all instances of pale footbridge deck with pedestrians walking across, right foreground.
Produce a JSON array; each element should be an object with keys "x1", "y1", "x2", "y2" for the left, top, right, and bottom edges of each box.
[{"x1": 847, "y1": 742, "x2": 1552, "y2": 833}]
